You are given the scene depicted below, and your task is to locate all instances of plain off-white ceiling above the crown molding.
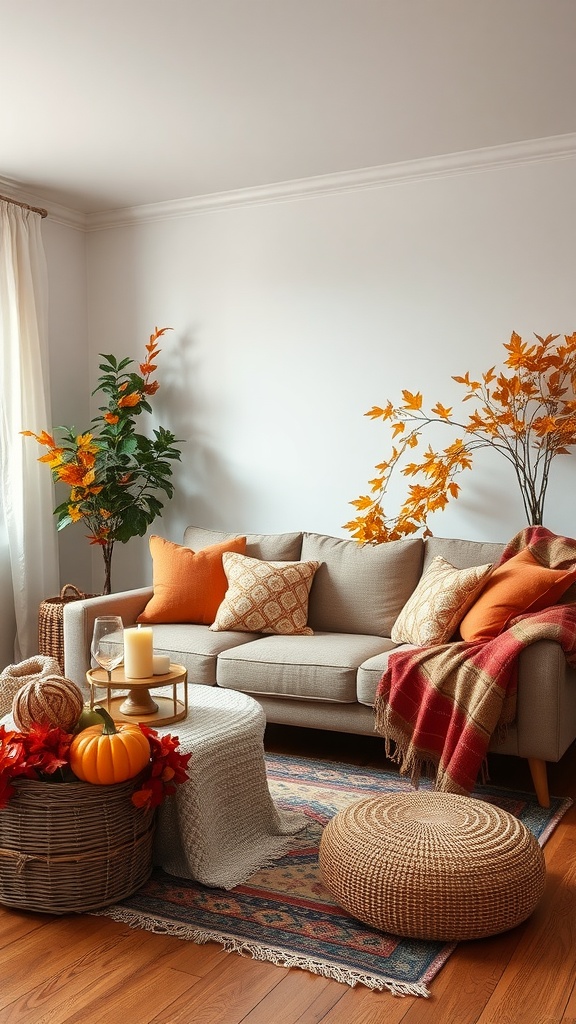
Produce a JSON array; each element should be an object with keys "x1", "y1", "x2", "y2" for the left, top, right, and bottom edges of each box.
[{"x1": 0, "y1": 0, "x2": 576, "y2": 213}]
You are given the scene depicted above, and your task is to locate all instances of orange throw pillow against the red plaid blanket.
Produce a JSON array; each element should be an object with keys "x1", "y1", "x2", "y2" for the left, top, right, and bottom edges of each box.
[{"x1": 460, "y1": 548, "x2": 576, "y2": 643}]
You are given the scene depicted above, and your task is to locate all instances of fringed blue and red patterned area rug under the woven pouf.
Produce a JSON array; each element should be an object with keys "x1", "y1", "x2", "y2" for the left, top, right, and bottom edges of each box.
[{"x1": 95, "y1": 755, "x2": 572, "y2": 996}]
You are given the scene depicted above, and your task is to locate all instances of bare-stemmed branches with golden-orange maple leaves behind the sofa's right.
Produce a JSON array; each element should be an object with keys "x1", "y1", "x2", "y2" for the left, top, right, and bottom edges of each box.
[{"x1": 344, "y1": 332, "x2": 576, "y2": 544}]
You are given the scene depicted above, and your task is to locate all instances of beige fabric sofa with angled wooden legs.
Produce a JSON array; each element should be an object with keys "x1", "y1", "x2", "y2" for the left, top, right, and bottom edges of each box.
[{"x1": 64, "y1": 526, "x2": 576, "y2": 805}]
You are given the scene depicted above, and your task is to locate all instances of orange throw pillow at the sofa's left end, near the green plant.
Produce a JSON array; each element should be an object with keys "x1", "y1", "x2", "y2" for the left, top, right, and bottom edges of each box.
[{"x1": 137, "y1": 536, "x2": 246, "y2": 626}]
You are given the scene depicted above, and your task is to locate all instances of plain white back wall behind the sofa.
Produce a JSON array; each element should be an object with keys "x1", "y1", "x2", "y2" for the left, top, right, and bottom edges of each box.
[{"x1": 78, "y1": 149, "x2": 576, "y2": 590}]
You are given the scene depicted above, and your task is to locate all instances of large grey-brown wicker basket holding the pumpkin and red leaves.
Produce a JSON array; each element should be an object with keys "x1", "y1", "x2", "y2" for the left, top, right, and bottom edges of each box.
[{"x1": 0, "y1": 779, "x2": 155, "y2": 913}]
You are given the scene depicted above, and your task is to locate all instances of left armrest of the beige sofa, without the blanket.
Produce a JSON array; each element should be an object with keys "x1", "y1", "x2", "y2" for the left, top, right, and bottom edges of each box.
[{"x1": 64, "y1": 587, "x2": 154, "y2": 692}]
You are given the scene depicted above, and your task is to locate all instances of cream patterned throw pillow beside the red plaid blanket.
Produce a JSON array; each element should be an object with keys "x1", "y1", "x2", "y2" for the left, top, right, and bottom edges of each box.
[{"x1": 390, "y1": 555, "x2": 492, "y2": 647}]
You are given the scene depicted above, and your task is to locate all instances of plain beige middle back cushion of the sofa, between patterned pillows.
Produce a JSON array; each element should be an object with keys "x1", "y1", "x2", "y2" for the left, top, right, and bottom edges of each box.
[{"x1": 301, "y1": 534, "x2": 423, "y2": 637}]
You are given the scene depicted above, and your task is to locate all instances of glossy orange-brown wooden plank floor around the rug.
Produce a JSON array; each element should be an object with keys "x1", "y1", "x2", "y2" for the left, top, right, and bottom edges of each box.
[{"x1": 0, "y1": 726, "x2": 576, "y2": 1024}]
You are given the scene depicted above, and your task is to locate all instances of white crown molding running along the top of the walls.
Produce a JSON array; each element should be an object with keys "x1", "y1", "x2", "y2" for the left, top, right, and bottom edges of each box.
[{"x1": 0, "y1": 132, "x2": 576, "y2": 231}]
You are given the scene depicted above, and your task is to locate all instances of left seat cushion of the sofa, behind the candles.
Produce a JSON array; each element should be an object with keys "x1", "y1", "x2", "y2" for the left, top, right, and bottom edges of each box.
[{"x1": 144, "y1": 623, "x2": 258, "y2": 686}]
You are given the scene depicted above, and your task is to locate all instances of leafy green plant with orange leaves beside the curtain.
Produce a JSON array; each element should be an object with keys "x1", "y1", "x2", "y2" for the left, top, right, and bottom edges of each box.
[{"x1": 23, "y1": 328, "x2": 180, "y2": 594}]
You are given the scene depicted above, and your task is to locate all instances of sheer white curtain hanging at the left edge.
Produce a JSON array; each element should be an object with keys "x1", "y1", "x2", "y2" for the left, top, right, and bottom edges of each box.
[{"x1": 0, "y1": 201, "x2": 59, "y2": 662}]
